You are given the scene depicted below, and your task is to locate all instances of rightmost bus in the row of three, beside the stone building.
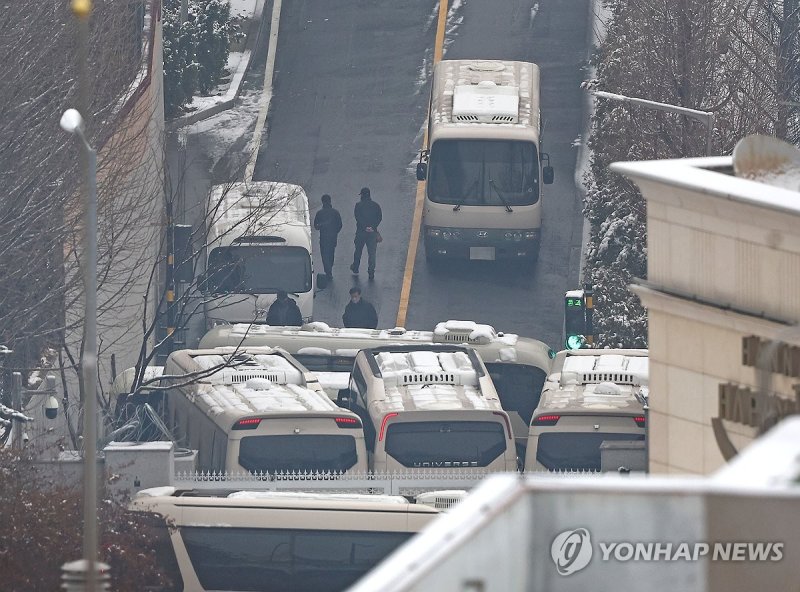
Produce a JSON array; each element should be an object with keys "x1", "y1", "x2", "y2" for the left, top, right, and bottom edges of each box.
[{"x1": 525, "y1": 349, "x2": 648, "y2": 471}]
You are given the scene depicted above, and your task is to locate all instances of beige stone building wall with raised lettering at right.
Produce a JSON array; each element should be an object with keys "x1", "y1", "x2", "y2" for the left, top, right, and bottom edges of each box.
[{"x1": 614, "y1": 158, "x2": 800, "y2": 474}]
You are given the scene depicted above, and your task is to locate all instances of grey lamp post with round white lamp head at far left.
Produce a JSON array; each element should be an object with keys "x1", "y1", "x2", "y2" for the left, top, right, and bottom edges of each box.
[{"x1": 61, "y1": 109, "x2": 97, "y2": 592}]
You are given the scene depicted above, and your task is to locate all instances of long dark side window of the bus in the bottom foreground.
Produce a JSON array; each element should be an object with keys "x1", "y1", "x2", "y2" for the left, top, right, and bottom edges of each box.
[{"x1": 181, "y1": 526, "x2": 413, "y2": 592}]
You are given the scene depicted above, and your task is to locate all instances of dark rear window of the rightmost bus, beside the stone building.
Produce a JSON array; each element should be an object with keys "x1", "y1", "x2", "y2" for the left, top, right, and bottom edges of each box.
[{"x1": 536, "y1": 430, "x2": 644, "y2": 471}]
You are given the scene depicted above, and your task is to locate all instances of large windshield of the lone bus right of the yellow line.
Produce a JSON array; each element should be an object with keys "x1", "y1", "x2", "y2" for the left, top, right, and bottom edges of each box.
[{"x1": 428, "y1": 140, "x2": 539, "y2": 208}]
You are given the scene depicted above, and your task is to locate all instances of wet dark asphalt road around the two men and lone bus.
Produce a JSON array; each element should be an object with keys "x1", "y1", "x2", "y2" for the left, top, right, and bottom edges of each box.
[{"x1": 250, "y1": 0, "x2": 589, "y2": 346}]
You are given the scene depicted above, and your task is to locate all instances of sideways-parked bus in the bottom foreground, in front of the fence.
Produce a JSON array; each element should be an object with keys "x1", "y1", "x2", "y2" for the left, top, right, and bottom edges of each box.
[{"x1": 131, "y1": 487, "x2": 439, "y2": 592}]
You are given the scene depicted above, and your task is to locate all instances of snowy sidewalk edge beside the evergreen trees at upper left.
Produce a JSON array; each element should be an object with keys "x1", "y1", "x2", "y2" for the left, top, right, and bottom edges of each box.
[{"x1": 166, "y1": 0, "x2": 267, "y2": 132}]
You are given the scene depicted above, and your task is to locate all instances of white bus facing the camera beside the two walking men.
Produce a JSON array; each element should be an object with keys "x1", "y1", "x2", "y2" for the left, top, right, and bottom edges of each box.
[{"x1": 201, "y1": 181, "x2": 314, "y2": 327}]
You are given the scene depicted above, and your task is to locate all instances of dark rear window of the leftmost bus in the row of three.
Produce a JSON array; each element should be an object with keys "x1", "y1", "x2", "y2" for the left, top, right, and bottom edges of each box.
[{"x1": 239, "y1": 432, "x2": 358, "y2": 473}]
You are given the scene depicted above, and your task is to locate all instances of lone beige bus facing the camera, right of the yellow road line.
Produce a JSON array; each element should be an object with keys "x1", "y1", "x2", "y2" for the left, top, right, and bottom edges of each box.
[{"x1": 417, "y1": 60, "x2": 553, "y2": 261}]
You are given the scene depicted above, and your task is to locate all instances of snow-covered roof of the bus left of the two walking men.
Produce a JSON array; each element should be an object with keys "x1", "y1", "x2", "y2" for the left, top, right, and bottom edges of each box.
[{"x1": 208, "y1": 181, "x2": 311, "y2": 248}]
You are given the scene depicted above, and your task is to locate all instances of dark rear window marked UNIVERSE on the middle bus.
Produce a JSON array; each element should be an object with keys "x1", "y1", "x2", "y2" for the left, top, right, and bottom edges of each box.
[{"x1": 386, "y1": 421, "x2": 506, "y2": 468}]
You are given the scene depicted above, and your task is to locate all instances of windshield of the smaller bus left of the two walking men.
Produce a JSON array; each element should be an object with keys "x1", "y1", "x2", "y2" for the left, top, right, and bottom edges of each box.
[{"x1": 206, "y1": 245, "x2": 311, "y2": 294}]
